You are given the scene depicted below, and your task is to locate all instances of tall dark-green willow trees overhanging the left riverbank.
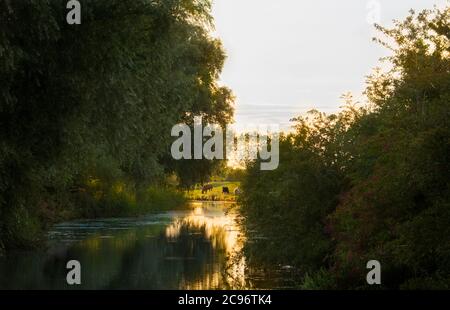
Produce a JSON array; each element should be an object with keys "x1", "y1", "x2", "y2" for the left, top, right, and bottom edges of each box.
[{"x1": 0, "y1": 0, "x2": 233, "y2": 249}]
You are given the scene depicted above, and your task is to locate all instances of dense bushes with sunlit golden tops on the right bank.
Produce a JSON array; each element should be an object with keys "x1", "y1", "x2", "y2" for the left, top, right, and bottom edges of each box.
[{"x1": 242, "y1": 8, "x2": 450, "y2": 289}]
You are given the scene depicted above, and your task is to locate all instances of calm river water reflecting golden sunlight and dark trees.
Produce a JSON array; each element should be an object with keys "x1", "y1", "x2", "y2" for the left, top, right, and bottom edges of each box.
[{"x1": 0, "y1": 202, "x2": 296, "y2": 289}]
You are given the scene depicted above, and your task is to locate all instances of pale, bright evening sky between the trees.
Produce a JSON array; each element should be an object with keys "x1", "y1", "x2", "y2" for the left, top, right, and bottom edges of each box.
[{"x1": 213, "y1": 0, "x2": 449, "y2": 129}]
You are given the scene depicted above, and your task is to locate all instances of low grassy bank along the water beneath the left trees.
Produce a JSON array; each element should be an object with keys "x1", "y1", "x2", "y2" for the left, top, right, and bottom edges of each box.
[{"x1": 0, "y1": 187, "x2": 187, "y2": 255}]
